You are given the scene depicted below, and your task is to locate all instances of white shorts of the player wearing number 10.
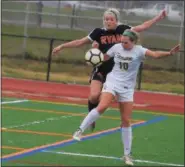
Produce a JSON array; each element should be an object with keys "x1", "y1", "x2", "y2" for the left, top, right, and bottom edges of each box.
[{"x1": 102, "y1": 82, "x2": 134, "y2": 102}]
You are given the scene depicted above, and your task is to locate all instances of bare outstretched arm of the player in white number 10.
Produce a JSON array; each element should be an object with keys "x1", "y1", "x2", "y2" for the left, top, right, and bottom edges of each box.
[{"x1": 145, "y1": 44, "x2": 180, "y2": 58}]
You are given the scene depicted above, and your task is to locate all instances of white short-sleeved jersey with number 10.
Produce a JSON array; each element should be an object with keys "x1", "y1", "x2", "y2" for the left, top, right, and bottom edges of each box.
[{"x1": 106, "y1": 43, "x2": 147, "y2": 91}]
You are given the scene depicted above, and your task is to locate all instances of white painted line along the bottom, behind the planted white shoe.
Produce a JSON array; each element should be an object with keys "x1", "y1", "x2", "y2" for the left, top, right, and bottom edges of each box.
[{"x1": 42, "y1": 150, "x2": 184, "y2": 166}]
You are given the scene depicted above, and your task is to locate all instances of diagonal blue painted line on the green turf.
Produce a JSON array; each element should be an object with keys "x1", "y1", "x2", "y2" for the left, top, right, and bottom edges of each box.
[{"x1": 1, "y1": 116, "x2": 167, "y2": 162}]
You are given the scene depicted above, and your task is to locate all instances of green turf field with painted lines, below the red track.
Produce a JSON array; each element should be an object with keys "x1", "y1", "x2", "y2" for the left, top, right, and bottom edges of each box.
[{"x1": 1, "y1": 98, "x2": 184, "y2": 166}]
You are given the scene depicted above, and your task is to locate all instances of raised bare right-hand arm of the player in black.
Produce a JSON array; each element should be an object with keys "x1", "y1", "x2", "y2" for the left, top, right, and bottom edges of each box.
[{"x1": 131, "y1": 10, "x2": 166, "y2": 32}]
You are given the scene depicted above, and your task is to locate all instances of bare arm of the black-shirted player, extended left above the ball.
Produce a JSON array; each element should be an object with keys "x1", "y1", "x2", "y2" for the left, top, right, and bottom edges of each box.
[{"x1": 52, "y1": 37, "x2": 91, "y2": 54}]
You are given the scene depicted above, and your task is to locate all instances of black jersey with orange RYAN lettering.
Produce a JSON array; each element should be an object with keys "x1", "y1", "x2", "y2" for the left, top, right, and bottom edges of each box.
[{"x1": 88, "y1": 24, "x2": 131, "y2": 76}]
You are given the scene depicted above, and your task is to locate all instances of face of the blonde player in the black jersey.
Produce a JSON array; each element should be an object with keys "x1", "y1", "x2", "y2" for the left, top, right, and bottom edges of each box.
[{"x1": 104, "y1": 14, "x2": 117, "y2": 30}]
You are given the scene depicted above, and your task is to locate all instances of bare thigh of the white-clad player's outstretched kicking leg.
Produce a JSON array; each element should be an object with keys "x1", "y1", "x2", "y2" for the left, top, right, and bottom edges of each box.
[{"x1": 97, "y1": 92, "x2": 114, "y2": 113}]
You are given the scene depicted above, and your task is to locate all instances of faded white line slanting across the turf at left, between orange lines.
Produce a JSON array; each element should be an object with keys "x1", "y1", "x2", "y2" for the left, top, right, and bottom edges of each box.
[{"x1": 2, "y1": 115, "x2": 85, "y2": 129}]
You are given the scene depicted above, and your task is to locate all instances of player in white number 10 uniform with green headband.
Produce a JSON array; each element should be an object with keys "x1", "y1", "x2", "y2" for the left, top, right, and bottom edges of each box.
[{"x1": 73, "y1": 30, "x2": 180, "y2": 165}]
